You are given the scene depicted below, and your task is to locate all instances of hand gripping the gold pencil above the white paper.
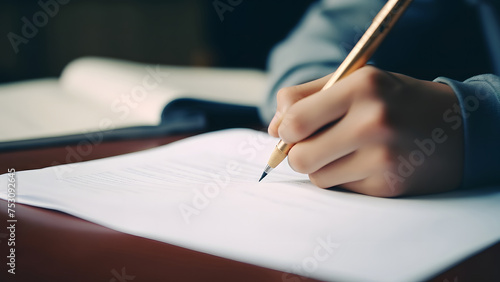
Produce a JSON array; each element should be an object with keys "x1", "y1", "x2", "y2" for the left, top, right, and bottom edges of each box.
[{"x1": 269, "y1": 66, "x2": 463, "y2": 197}]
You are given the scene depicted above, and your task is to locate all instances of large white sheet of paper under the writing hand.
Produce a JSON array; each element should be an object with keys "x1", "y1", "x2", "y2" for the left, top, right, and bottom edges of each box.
[{"x1": 0, "y1": 129, "x2": 500, "y2": 281}]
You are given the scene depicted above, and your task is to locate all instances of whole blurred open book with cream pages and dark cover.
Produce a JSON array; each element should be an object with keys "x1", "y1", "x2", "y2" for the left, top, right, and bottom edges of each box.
[{"x1": 0, "y1": 57, "x2": 266, "y2": 149}]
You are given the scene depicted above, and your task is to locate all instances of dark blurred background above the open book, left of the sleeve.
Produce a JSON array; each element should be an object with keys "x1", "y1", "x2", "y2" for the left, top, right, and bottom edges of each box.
[{"x1": 0, "y1": 0, "x2": 313, "y2": 82}]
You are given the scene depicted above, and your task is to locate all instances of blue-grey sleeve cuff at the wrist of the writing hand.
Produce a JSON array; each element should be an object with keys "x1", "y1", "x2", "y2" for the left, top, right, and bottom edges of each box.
[{"x1": 435, "y1": 74, "x2": 500, "y2": 188}]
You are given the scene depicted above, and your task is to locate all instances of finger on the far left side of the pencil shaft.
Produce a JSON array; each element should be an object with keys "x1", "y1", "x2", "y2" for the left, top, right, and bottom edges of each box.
[{"x1": 268, "y1": 75, "x2": 330, "y2": 137}]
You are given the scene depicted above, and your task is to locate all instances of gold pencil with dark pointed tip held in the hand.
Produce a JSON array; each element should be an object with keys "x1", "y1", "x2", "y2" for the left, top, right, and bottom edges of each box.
[{"x1": 259, "y1": 0, "x2": 412, "y2": 182}]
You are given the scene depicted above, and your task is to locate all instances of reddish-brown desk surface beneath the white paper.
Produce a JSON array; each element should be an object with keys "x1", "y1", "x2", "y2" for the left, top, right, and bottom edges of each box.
[{"x1": 0, "y1": 135, "x2": 500, "y2": 282}]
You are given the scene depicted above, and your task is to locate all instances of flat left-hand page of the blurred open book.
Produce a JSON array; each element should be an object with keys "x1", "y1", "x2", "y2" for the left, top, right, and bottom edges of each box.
[{"x1": 0, "y1": 78, "x2": 117, "y2": 142}]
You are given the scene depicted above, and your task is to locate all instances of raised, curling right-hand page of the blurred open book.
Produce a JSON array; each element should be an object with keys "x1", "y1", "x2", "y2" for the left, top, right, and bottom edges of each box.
[{"x1": 61, "y1": 57, "x2": 266, "y2": 124}]
